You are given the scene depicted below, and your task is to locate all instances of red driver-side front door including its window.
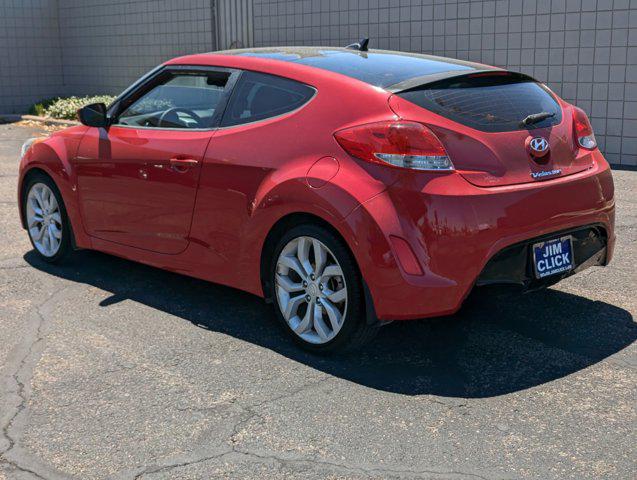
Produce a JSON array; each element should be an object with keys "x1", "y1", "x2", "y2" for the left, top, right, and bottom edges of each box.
[{"x1": 76, "y1": 67, "x2": 237, "y2": 254}]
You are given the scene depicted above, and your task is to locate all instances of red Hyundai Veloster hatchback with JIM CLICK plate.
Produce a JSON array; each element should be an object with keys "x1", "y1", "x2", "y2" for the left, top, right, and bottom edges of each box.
[{"x1": 18, "y1": 45, "x2": 614, "y2": 351}]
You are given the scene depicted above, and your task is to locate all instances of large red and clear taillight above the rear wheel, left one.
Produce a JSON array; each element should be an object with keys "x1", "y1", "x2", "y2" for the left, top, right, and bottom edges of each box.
[{"x1": 334, "y1": 121, "x2": 453, "y2": 170}]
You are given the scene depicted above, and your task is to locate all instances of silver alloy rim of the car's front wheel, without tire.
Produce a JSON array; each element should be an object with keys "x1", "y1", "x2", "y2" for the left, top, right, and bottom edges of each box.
[{"x1": 26, "y1": 183, "x2": 62, "y2": 257}]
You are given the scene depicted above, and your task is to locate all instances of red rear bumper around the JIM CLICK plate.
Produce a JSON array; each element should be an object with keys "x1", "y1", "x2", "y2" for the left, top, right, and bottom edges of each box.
[{"x1": 345, "y1": 152, "x2": 615, "y2": 320}]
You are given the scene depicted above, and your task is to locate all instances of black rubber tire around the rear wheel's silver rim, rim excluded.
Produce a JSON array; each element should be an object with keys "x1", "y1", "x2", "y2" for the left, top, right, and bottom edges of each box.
[{"x1": 267, "y1": 224, "x2": 379, "y2": 353}]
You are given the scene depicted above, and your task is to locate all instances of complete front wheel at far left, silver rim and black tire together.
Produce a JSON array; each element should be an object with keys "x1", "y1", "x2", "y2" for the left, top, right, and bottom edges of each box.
[{"x1": 22, "y1": 172, "x2": 72, "y2": 263}]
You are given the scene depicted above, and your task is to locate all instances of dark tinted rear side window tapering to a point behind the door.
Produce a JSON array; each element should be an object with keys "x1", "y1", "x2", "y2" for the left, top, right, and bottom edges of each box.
[{"x1": 221, "y1": 71, "x2": 315, "y2": 127}]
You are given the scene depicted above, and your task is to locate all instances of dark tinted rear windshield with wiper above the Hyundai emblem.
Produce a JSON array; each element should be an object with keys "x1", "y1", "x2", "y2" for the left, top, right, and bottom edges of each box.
[{"x1": 397, "y1": 73, "x2": 562, "y2": 132}]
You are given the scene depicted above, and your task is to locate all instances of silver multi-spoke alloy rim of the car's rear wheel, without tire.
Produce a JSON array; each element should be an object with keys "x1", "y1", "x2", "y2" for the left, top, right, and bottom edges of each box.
[{"x1": 275, "y1": 236, "x2": 347, "y2": 344}]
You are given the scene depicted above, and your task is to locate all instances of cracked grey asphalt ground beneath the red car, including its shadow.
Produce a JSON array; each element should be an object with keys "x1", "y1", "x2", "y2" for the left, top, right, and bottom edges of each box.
[{"x1": 0, "y1": 125, "x2": 637, "y2": 480}]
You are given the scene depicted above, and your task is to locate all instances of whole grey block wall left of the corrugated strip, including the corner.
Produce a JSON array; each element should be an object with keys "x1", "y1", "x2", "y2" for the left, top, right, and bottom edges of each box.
[{"x1": 0, "y1": 0, "x2": 216, "y2": 113}]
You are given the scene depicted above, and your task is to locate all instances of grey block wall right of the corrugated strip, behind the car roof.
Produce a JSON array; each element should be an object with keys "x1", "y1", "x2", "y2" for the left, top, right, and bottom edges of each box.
[{"x1": 253, "y1": 0, "x2": 637, "y2": 165}]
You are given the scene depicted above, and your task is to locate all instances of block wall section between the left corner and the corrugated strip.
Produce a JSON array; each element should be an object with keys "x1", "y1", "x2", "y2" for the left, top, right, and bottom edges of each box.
[{"x1": 59, "y1": 0, "x2": 215, "y2": 94}]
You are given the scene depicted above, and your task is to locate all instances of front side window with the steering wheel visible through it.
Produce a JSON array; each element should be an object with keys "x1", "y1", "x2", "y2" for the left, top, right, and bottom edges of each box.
[{"x1": 115, "y1": 71, "x2": 230, "y2": 128}]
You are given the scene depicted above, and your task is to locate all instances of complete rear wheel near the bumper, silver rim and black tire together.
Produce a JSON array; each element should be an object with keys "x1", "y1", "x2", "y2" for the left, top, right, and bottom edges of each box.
[{"x1": 268, "y1": 224, "x2": 379, "y2": 353}]
